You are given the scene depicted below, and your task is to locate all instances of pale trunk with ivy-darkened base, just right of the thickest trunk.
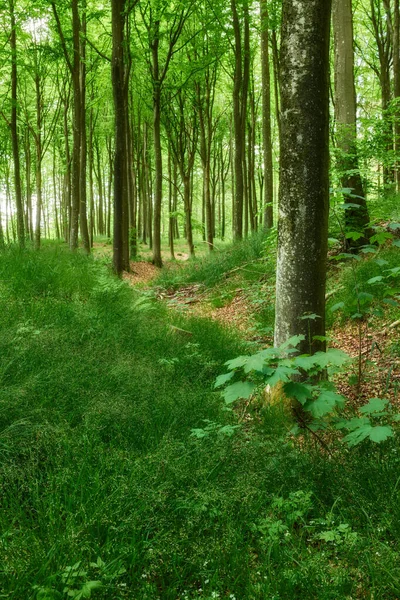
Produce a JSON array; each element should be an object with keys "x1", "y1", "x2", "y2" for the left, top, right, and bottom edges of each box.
[{"x1": 332, "y1": 0, "x2": 369, "y2": 247}]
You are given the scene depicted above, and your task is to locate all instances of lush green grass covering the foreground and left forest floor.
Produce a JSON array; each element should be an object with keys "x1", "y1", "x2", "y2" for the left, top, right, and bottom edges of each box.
[{"x1": 0, "y1": 248, "x2": 400, "y2": 600}]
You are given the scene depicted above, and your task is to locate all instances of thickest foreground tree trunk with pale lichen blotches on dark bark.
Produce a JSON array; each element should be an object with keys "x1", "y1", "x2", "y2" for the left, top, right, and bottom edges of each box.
[{"x1": 275, "y1": 0, "x2": 330, "y2": 352}]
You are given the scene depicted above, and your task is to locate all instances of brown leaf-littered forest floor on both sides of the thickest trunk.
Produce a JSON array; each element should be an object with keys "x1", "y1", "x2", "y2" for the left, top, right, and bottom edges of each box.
[{"x1": 118, "y1": 241, "x2": 400, "y2": 408}]
